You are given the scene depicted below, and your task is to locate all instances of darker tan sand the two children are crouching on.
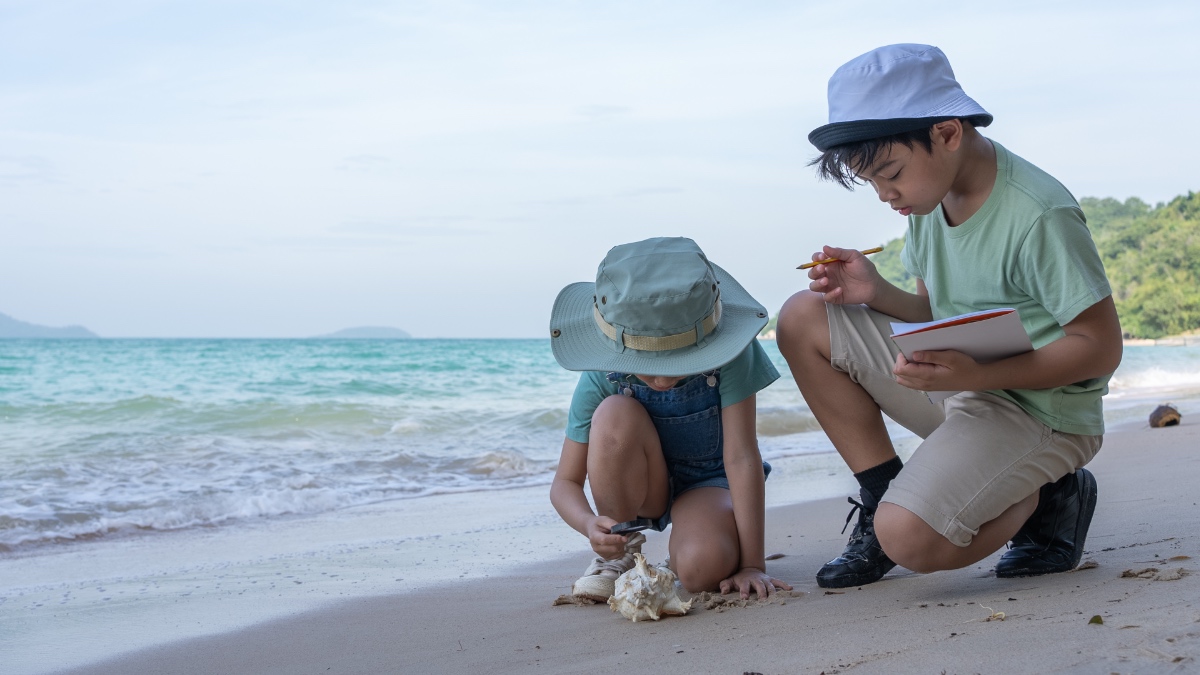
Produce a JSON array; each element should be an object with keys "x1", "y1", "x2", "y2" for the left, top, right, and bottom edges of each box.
[{"x1": 21, "y1": 416, "x2": 1200, "y2": 674}]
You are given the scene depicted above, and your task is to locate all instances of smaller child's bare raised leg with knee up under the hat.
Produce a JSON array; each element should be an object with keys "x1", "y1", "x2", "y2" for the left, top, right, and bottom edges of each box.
[{"x1": 588, "y1": 395, "x2": 670, "y2": 522}]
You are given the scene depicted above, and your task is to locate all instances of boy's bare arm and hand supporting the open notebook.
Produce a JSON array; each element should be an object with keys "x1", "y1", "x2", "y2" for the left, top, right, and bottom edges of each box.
[{"x1": 894, "y1": 295, "x2": 1122, "y2": 392}]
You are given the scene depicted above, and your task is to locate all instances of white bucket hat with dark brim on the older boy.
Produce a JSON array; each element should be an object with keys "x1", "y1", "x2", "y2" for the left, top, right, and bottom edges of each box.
[{"x1": 809, "y1": 44, "x2": 992, "y2": 153}]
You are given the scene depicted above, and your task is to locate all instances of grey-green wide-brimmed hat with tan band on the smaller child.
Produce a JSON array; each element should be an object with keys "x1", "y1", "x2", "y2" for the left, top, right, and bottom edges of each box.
[{"x1": 550, "y1": 237, "x2": 767, "y2": 377}]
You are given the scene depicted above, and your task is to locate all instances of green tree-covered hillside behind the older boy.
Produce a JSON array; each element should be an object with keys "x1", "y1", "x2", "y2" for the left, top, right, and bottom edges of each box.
[{"x1": 787, "y1": 192, "x2": 1200, "y2": 338}]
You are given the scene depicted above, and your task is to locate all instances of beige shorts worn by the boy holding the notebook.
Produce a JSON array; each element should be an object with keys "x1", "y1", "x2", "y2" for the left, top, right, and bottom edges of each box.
[{"x1": 826, "y1": 305, "x2": 1104, "y2": 546}]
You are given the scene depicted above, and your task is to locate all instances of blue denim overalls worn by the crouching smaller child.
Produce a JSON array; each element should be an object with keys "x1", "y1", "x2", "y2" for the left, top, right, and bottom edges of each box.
[{"x1": 606, "y1": 370, "x2": 770, "y2": 532}]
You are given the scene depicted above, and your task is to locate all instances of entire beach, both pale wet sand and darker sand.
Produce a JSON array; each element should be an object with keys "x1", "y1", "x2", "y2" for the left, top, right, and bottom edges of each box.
[{"x1": 0, "y1": 417, "x2": 1200, "y2": 673}]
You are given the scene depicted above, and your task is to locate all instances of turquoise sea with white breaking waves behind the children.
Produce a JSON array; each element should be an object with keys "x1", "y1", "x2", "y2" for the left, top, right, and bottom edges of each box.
[{"x1": 0, "y1": 340, "x2": 1200, "y2": 552}]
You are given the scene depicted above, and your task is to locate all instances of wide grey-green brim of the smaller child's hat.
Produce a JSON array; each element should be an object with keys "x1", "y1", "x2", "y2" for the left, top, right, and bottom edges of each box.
[{"x1": 550, "y1": 263, "x2": 767, "y2": 377}]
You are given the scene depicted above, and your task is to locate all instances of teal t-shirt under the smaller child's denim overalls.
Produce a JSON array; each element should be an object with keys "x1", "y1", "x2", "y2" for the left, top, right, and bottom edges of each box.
[{"x1": 566, "y1": 340, "x2": 779, "y2": 443}]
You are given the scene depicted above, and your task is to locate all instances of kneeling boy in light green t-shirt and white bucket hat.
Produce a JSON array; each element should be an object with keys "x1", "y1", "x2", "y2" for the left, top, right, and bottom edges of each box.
[{"x1": 778, "y1": 44, "x2": 1121, "y2": 587}]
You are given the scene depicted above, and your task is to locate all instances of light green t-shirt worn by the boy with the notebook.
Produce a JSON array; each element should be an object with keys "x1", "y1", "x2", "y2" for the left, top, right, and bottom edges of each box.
[{"x1": 901, "y1": 141, "x2": 1112, "y2": 435}]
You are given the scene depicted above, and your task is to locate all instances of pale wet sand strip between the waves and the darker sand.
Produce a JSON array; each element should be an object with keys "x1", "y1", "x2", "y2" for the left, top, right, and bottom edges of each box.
[{"x1": 0, "y1": 436, "x2": 897, "y2": 674}]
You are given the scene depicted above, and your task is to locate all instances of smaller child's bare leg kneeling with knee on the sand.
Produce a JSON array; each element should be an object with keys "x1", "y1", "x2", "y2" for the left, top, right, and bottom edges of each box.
[{"x1": 670, "y1": 488, "x2": 742, "y2": 593}]
